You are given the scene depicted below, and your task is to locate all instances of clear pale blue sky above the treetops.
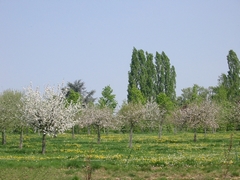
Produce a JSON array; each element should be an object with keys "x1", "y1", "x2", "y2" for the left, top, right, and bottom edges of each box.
[{"x1": 0, "y1": 0, "x2": 240, "y2": 104}]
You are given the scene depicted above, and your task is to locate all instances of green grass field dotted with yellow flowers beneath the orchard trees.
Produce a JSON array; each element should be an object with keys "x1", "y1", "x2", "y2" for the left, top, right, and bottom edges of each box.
[{"x1": 0, "y1": 132, "x2": 240, "y2": 180}]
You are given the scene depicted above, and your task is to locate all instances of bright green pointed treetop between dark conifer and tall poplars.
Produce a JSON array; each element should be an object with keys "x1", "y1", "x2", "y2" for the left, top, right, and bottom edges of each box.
[{"x1": 98, "y1": 85, "x2": 117, "y2": 110}]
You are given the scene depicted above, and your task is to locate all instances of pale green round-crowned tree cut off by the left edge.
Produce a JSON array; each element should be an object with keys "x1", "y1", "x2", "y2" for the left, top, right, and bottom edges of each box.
[{"x1": 0, "y1": 90, "x2": 22, "y2": 145}]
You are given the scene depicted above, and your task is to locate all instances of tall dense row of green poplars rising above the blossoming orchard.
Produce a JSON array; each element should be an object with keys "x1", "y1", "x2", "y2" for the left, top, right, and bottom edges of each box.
[{"x1": 127, "y1": 48, "x2": 176, "y2": 103}]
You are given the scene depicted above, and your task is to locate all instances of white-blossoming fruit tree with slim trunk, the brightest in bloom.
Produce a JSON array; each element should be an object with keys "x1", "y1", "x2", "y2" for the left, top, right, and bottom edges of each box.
[{"x1": 23, "y1": 83, "x2": 81, "y2": 154}]
